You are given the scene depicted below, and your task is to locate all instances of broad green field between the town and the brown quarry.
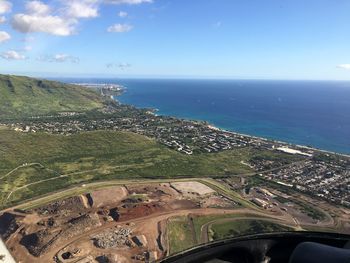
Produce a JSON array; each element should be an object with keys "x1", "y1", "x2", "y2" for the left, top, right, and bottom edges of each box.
[{"x1": 0, "y1": 129, "x2": 262, "y2": 208}]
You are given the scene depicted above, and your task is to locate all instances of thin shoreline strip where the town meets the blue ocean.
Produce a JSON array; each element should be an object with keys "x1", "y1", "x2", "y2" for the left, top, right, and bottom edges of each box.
[{"x1": 113, "y1": 93, "x2": 350, "y2": 158}]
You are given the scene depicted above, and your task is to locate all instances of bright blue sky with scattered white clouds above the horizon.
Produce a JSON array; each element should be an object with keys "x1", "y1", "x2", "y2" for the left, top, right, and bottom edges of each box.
[{"x1": 0, "y1": 0, "x2": 350, "y2": 80}]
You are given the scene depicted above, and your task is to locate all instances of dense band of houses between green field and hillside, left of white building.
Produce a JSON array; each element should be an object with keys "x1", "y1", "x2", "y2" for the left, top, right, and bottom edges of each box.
[{"x1": 4, "y1": 112, "x2": 272, "y2": 155}]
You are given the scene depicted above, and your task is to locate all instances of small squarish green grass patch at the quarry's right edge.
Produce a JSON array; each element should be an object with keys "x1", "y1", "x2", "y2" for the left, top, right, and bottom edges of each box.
[{"x1": 167, "y1": 216, "x2": 195, "y2": 255}]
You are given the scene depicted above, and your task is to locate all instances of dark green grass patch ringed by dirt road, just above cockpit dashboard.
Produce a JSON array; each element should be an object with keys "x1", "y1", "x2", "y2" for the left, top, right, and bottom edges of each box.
[{"x1": 210, "y1": 219, "x2": 293, "y2": 240}]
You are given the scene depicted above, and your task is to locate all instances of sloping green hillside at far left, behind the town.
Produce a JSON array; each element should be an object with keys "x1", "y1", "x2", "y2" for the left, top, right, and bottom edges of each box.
[{"x1": 0, "y1": 75, "x2": 103, "y2": 119}]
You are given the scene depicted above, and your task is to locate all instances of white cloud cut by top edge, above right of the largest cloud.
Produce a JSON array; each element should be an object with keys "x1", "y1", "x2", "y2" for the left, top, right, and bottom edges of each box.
[{"x1": 65, "y1": 0, "x2": 98, "y2": 18}]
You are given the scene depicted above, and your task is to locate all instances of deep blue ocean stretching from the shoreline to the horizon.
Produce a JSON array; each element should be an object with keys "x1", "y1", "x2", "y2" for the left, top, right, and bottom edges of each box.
[{"x1": 60, "y1": 79, "x2": 350, "y2": 154}]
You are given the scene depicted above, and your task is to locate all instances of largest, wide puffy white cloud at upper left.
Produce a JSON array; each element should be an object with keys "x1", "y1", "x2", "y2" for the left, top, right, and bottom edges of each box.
[{"x1": 11, "y1": 14, "x2": 77, "y2": 36}]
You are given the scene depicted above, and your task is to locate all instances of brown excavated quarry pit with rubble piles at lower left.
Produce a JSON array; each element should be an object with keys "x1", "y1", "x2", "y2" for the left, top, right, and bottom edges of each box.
[{"x1": 0, "y1": 182, "x2": 236, "y2": 263}]
